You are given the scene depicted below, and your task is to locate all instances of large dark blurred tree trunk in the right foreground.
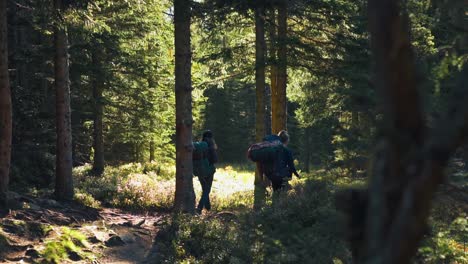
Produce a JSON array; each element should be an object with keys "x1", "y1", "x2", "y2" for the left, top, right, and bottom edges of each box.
[{"x1": 364, "y1": 0, "x2": 425, "y2": 263}]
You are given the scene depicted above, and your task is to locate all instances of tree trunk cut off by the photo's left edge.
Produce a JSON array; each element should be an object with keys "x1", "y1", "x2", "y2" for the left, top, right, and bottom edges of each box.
[{"x1": 0, "y1": 0, "x2": 12, "y2": 209}]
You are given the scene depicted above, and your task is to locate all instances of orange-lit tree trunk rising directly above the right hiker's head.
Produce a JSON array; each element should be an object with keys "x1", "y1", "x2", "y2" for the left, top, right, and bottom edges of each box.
[{"x1": 271, "y1": 0, "x2": 288, "y2": 133}]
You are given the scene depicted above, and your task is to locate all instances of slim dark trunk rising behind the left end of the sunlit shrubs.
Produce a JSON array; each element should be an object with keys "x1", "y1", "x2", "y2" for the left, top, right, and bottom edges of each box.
[{"x1": 92, "y1": 50, "x2": 104, "y2": 176}]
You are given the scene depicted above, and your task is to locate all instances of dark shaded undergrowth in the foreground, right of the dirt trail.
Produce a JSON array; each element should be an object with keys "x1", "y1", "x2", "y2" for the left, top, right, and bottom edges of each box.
[{"x1": 155, "y1": 175, "x2": 349, "y2": 263}]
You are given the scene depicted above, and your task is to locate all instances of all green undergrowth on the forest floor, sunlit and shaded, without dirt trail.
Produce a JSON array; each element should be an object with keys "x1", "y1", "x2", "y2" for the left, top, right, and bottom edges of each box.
[{"x1": 71, "y1": 163, "x2": 468, "y2": 263}]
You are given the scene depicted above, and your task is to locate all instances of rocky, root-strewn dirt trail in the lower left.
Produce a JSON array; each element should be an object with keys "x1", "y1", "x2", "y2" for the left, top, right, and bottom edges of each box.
[{"x1": 0, "y1": 196, "x2": 166, "y2": 264}]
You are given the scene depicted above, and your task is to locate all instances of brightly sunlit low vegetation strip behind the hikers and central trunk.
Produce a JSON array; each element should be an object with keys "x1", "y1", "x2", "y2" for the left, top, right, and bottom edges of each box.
[{"x1": 74, "y1": 162, "x2": 255, "y2": 211}]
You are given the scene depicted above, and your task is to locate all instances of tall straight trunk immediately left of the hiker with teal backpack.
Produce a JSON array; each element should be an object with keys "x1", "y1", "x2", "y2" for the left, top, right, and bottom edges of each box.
[{"x1": 174, "y1": 0, "x2": 195, "y2": 214}]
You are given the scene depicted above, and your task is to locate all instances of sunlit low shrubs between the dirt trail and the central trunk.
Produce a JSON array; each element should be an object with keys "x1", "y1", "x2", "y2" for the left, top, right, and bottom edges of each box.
[{"x1": 74, "y1": 163, "x2": 174, "y2": 211}]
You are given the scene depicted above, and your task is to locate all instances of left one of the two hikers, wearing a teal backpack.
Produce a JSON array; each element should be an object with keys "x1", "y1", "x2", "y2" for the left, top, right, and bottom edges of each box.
[{"x1": 194, "y1": 130, "x2": 218, "y2": 213}]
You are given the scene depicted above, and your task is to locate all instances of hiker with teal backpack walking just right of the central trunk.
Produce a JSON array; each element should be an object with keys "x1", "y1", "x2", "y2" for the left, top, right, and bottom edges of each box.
[{"x1": 193, "y1": 130, "x2": 218, "y2": 213}]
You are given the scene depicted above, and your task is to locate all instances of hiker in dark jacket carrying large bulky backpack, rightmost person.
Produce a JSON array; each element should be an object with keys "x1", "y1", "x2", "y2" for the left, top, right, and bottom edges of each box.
[{"x1": 248, "y1": 130, "x2": 300, "y2": 191}]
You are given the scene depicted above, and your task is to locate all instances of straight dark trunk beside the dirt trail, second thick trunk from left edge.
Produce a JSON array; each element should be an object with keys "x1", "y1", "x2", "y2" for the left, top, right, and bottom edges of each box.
[{"x1": 54, "y1": 0, "x2": 73, "y2": 200}]
